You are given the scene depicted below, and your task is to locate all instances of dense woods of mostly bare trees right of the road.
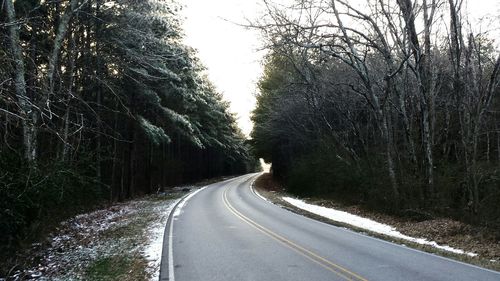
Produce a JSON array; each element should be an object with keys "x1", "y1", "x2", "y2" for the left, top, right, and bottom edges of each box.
[{"x1": 252, "y1": 0, "x2": 500, "y2": 225}]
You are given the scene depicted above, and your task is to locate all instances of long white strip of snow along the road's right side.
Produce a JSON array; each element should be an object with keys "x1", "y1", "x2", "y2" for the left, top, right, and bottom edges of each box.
[{"x1": 282, "y1": 197, "x2": 477, "y2": 257}]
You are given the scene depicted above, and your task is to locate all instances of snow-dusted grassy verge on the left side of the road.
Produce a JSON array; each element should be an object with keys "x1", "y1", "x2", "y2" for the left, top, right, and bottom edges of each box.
[{"x1": 8, "y1": 188, "x2": 189, "y2": 281}]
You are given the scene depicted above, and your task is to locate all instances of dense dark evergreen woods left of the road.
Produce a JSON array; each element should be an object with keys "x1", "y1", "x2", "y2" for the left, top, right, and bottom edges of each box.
[{"x1": 0, "y1": 0, "x2": 256, "y2": 260}]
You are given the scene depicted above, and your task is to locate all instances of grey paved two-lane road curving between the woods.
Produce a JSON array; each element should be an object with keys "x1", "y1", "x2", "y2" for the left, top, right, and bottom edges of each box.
[{"x1": 160, "y1": 174, "x2": 500, "y2": 281}]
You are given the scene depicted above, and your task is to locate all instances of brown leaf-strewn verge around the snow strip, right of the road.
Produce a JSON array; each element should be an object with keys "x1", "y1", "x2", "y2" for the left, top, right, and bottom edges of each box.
[{"x1": 254, "y1": 174, "x2": 500, "y2": 271}]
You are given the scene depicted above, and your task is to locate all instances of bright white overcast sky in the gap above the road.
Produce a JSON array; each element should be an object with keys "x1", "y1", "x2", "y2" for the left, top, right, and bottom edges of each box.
[{"x1": 180, "y1": 0, "x2": 500, "y2": 135}]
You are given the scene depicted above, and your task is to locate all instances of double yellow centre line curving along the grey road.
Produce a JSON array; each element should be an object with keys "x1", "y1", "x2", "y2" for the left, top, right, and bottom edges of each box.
[{"x1": 222, "y1": 188, "x2": 368, "y2": 281}]
